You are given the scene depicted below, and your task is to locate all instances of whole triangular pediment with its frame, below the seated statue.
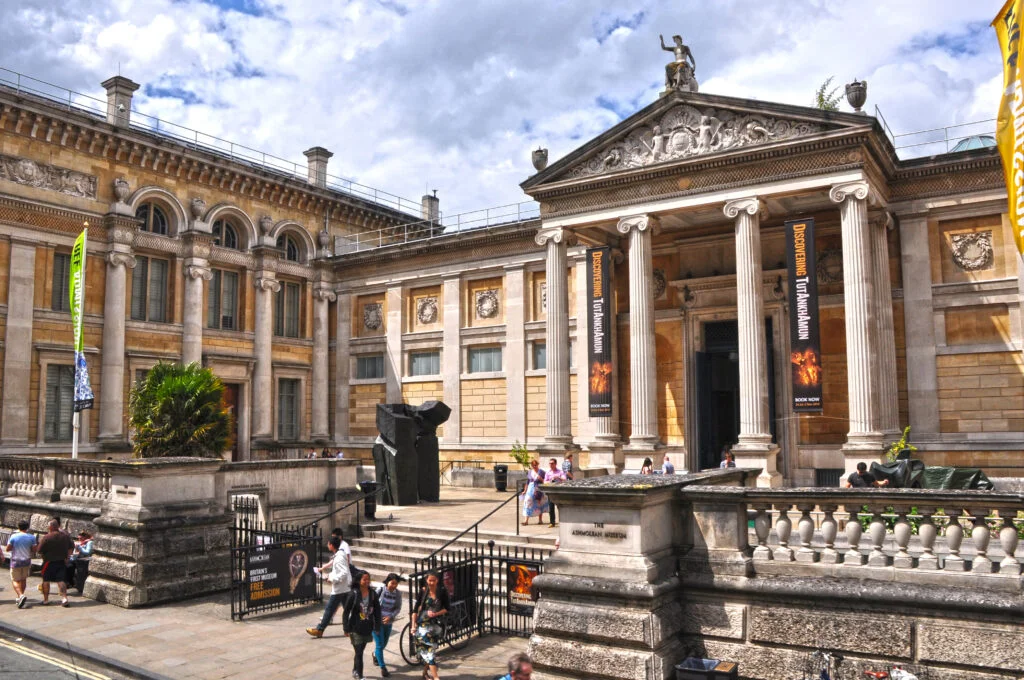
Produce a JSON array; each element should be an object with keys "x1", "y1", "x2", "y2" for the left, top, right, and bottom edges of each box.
[{"x1": 522, "y1": 93, "x2": 874, "y2": 192}]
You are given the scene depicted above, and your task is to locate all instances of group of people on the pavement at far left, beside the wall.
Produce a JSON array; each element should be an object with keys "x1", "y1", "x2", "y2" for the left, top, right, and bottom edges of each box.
[{"x1": 0, "y1": 517, "x2": 92, "y2": 609}]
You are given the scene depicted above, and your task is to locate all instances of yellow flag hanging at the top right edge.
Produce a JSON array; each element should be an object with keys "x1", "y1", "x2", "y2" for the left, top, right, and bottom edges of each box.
[{"x1": 992, "y1": 0, "x2": 1024, "y2": 254}]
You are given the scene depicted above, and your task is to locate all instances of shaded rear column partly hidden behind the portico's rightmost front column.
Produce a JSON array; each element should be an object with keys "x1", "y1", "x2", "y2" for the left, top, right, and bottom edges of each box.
[{"x1": 869, "y1": 213, "x2": 901, "y2": 438}]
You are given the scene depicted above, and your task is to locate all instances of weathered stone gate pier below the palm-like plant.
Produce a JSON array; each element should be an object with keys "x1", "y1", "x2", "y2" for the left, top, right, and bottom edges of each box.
[{"x1": 85, "y1": 458, "x2": 231, "y2": 607}]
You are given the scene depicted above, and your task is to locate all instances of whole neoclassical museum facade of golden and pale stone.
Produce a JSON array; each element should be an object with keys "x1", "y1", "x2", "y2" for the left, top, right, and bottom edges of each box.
[{"x1": 0, "y1": 71, "x2": 1024, "y2": 485}]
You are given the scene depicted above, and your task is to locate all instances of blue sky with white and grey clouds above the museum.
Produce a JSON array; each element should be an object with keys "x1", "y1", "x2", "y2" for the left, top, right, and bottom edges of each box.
[{"x1": 0, "y1": 0, "x2": 1002, "y2": 214}]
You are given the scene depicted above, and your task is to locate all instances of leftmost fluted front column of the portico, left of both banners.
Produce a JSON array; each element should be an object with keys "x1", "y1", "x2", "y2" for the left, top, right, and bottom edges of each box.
[{"x1": 536, "y1": 227, "x2": 572, "y2": 453}]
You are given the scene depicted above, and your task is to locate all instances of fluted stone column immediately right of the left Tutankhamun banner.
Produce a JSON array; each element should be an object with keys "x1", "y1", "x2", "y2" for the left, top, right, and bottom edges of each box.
[{"x1": 617, "y1": 215, "x2": 658, "y2": 458}]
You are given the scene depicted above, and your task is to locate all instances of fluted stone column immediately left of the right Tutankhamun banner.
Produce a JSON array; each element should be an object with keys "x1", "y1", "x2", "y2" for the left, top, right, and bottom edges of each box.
[{"x1": 724, "y1": 198, "x2": 782, "y2": 486}]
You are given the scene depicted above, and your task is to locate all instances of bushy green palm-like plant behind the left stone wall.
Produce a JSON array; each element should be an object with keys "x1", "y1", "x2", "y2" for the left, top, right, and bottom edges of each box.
[{"x1": 129, "y1": 364, "x2": 231, "y2": 458}]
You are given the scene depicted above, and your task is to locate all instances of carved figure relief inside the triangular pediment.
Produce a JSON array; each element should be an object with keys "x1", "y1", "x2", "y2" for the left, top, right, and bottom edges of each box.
[{"x1": 566, "y1": 103, "x2": 825, "y2": 178}]
